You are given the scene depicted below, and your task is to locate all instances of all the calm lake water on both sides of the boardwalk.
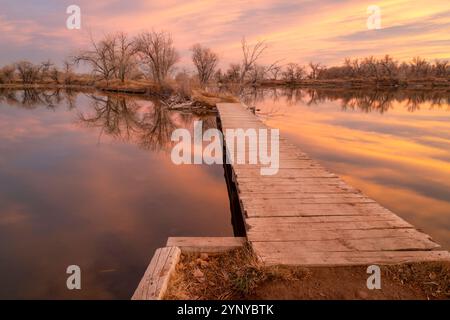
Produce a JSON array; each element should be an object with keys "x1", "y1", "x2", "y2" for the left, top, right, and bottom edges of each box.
[{"x1": 0, "y1": 89, "x2": 450, "y2": 299}]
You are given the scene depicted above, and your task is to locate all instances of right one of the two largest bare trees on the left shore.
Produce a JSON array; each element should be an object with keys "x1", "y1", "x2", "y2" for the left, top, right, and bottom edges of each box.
[{"x1": 136, "y1": 31, "x2": 179, "y2": 84}]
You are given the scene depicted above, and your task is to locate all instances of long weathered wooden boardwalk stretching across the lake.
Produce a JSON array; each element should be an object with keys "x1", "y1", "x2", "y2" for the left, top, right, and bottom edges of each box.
[{"x1": 217, "y1": 103, "x2": 450, "y2": 266}]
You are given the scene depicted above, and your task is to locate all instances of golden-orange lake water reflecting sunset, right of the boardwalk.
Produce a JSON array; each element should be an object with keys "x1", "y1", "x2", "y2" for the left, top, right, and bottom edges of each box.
[{"x1": 246, "y1": 89, "x2": 450, "y2": 250}]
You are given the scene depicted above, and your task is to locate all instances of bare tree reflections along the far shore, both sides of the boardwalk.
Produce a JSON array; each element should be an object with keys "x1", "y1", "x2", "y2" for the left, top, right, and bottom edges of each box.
[{"x1": 0, "y1": 87, "x2": 450, "y2": 150}]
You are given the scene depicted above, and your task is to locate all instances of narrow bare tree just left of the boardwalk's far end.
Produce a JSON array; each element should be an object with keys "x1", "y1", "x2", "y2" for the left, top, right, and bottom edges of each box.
[{"x1": 191, "y1": 44, "x2": 219, "y2": 86}]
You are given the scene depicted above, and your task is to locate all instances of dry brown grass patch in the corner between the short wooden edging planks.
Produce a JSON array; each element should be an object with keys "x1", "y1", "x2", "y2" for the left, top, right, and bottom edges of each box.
[{"x1": 165, "y1": 246, "x2": 307, "y2": 300}]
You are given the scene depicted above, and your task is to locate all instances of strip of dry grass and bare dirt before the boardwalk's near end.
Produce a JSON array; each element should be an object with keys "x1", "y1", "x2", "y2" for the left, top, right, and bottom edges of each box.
[{"x1": 165, "y1": 246, "x2": 450, "y2": 300}]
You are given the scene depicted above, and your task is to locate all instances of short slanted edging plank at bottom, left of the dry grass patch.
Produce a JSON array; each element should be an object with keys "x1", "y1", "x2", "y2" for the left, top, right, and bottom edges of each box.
[{"x1": 131, "y1": 247, "x2": 181, "y2": 300}]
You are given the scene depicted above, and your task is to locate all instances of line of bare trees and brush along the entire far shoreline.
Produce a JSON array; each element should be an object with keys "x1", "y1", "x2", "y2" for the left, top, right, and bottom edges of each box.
[{"x1": 0, "y1": 30, "x2": 450, "y2": 87}]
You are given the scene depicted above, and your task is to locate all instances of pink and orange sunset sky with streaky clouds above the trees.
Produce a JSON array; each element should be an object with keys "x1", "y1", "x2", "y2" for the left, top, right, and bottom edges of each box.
[{"x1": 0, "y1": 0, "x2": 450, "y2": 68}]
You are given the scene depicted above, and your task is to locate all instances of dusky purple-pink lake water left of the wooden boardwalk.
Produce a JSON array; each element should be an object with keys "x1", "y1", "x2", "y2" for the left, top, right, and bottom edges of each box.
[{"x1": 0, "y1": 92, "x2": 233, "y2": 299}]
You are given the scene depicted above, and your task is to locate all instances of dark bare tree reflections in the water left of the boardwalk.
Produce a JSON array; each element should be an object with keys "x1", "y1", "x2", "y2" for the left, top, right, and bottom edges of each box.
[{"x1": 0, "y1": 89, "x2": 220, "y2": 150}]
